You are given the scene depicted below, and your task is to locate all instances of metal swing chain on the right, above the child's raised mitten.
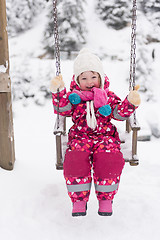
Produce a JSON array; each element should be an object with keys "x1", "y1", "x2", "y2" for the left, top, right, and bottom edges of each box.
[{"x1": 129, "y1": 0, "x2": 137, "y2": 124}]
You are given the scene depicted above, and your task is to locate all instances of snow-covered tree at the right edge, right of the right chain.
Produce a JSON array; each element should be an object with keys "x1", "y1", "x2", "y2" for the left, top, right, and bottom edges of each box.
[{"x1": 136, "y1": 0, "x2": 160, "y2": 100}]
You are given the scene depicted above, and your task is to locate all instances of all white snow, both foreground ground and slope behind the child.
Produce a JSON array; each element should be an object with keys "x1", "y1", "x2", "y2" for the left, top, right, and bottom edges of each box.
[{"x1": 0, "y1": 2, "x2": 160, "y2": 240}]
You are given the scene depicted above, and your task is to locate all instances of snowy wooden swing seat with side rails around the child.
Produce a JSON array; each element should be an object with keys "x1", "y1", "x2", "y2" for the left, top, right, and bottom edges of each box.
[{"x1": 53, "y1": 115, "x2": 140, "y2": 170}]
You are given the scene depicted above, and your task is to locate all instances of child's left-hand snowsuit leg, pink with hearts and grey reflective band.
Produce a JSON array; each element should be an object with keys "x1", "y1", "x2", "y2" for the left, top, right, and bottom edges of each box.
[{"x1": 63, "y1": 139, "x2": 92, "y2": 202}]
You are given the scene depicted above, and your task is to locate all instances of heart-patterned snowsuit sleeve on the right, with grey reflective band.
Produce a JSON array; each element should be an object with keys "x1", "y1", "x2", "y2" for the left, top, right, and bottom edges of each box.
[{"x1": 109, "y1": 92, "x2": 137, "y2": 121}]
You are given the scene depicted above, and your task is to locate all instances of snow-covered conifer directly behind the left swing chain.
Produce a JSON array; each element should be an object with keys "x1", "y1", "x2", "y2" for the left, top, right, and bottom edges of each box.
[{"x1": 44, "y1": 0, "x2": 86, "y2": 54}]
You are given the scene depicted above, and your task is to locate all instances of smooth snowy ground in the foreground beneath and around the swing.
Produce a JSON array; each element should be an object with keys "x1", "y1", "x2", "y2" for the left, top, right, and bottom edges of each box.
[{"x1": 0, "y1": 101, "x2": 160, "y2": 240}]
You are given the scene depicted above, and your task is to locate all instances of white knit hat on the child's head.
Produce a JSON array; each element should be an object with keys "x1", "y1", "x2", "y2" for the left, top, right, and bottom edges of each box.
[{"x1": 73, "y1": 48, "x2": 105, "y2": 88}]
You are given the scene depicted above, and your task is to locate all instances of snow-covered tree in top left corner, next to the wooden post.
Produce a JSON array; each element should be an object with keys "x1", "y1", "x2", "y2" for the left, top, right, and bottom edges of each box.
[{"x1": 6, "y1": 0, "x2": 44, "y2": 36}]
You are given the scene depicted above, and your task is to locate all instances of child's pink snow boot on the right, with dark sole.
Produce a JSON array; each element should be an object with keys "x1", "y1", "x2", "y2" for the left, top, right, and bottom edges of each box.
[{"x1": 98, "y1": 200, "x2": 112, "y2": 216}]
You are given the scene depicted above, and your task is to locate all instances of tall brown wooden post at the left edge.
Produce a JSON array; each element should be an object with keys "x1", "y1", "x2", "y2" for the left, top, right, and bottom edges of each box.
[{"x1": 0, "y1": 0, "x2": 15, "y2": 170}]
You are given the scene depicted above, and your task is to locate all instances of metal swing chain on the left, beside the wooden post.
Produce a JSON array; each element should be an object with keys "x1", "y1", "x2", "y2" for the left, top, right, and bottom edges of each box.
[{"x1": 53, "y1": 0, "x2": 61, "y2": 129}]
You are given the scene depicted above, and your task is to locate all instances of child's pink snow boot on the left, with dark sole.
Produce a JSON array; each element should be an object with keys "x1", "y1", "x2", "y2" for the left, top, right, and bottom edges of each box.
[{"x1": 72, "y1": 201, "x2": 87, "y2": 217}]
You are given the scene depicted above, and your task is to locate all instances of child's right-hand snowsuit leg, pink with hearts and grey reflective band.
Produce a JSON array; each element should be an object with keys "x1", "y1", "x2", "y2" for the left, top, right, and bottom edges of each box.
[{"x1": 93, "y1": 137, "x2": 124, "y2": 200}]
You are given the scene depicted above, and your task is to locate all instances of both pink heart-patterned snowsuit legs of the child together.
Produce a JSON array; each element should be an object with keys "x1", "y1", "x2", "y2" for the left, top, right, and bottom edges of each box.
[{"x1": 64, "y1": 136, "x2": 124, "y2": 202}]
